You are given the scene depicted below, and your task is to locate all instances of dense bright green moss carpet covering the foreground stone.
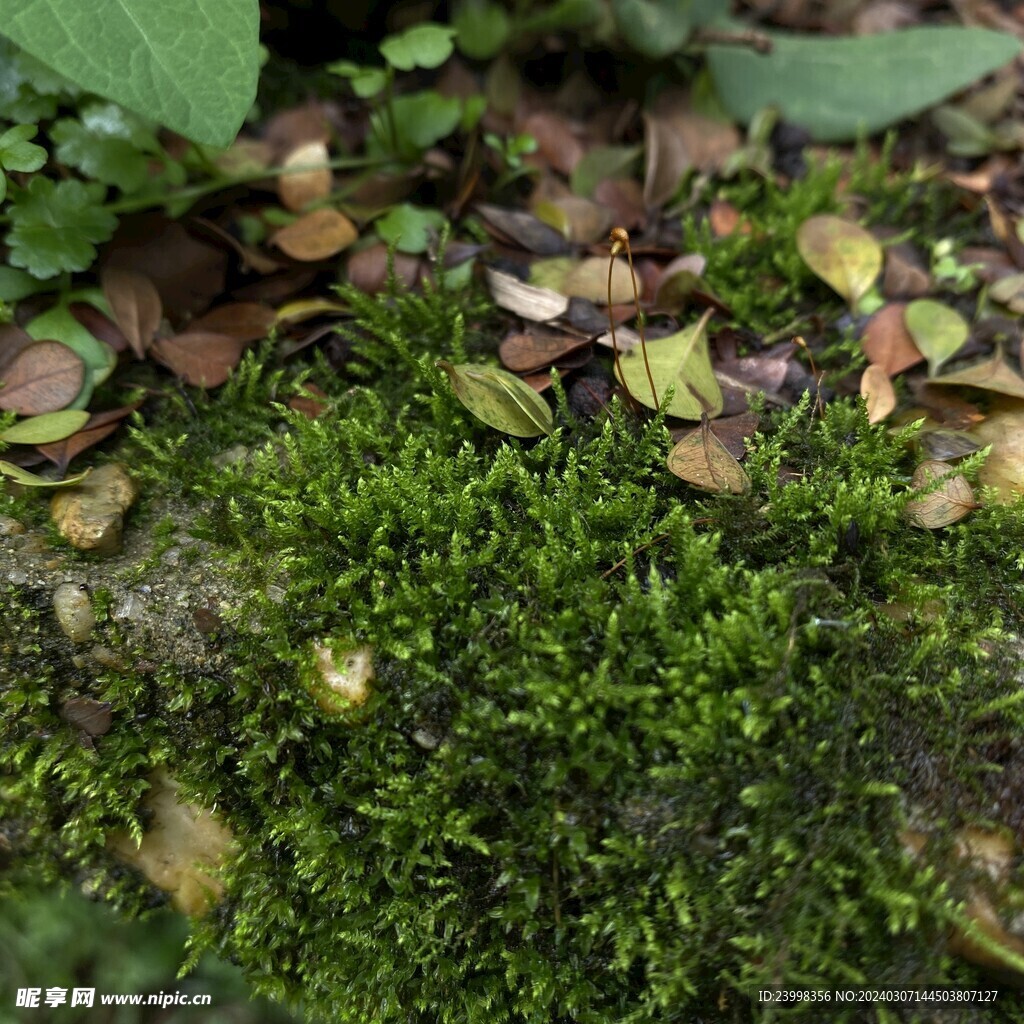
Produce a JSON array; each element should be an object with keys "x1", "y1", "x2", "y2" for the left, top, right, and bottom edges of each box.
[{"x1": 0, "y1": 195, "x2": 1024, "y2": 1024}]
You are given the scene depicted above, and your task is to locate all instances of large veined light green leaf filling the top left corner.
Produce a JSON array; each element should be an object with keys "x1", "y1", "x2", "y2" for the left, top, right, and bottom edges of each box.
[{"x1": 0, "y1": 0, "x2": 259, "y2": 146}]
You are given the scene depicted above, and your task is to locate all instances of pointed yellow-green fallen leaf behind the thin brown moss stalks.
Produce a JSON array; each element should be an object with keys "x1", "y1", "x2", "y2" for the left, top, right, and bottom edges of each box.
[{"x1": 616, "y1": 310, "x2": 724, "y2": 420}]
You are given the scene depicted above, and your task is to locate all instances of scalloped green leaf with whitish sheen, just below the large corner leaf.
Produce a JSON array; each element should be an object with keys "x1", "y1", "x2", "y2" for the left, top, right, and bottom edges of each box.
[{"x1": 50, "y1": 103, "x2": 159, "y2": 191}]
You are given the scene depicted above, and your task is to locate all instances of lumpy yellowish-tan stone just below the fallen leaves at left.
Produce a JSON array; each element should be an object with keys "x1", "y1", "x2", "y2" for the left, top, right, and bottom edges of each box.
[{"x1": 50, "y1": 464, "x2": 138, "y2": 555}]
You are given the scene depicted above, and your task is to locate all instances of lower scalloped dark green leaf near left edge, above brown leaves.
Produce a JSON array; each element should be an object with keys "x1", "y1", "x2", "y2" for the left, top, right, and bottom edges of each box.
[{"x1": 6, "y1": 177, "x2": 118, "y2": 279}]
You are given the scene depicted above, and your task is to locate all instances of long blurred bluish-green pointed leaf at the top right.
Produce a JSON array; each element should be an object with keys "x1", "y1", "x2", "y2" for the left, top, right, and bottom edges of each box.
[{"x1": 708, "y1": 27, "x2": 1021, "y2": 142}]
